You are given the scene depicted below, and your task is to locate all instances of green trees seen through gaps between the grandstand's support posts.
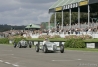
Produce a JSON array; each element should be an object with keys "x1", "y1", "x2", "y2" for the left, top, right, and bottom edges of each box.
[{"x1": 50, "y1": 12, "x2": 88, "y2": 25}]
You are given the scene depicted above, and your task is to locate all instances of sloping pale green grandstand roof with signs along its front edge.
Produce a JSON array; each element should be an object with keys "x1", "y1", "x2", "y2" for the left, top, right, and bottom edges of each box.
[{"x1": 49, "y1": 0, "x2": 98, "y2": 12}]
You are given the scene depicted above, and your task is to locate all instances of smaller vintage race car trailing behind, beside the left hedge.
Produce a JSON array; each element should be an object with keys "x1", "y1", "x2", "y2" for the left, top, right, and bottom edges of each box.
[{"x1": 14, "y1": 40, "x2": 32, "y2": 48}]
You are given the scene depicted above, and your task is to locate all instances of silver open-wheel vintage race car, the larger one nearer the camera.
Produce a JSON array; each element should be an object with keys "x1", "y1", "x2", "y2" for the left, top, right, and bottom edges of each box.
[{"x1": 35, "y1": 42, "x2": 64, "y2": 53}]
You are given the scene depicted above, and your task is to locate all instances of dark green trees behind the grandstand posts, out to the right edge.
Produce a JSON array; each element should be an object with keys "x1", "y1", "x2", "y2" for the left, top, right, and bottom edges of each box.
[{"x1": 50, "y1": 12, "x2": 98, "y2": 26}]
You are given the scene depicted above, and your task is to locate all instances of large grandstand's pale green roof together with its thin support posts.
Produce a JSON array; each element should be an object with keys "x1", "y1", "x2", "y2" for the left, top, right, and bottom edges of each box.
[{"x1": 49, "y1": 0, "x2": 98, "y2": 28}]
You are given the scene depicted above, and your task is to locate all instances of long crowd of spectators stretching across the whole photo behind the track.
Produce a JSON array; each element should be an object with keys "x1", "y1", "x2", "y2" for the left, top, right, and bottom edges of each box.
[{"x1": 0, "y1": 23, "x2": 98, "y2": 37}]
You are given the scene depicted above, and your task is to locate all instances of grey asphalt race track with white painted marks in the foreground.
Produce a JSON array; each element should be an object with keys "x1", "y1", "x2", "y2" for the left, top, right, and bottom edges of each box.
[{"x1": 0, "y1": 45, "x2": 98, "y2": 67}]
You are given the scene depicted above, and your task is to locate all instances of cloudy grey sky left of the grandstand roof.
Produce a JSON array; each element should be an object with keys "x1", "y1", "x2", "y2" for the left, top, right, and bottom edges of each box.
[{"x1": 0, "y1": 0, "x2": 57, "y2": 25}]
